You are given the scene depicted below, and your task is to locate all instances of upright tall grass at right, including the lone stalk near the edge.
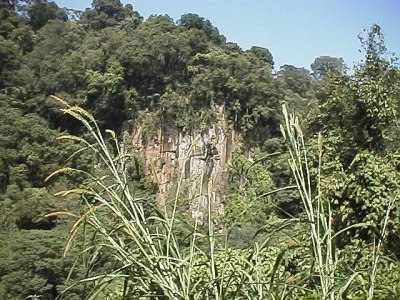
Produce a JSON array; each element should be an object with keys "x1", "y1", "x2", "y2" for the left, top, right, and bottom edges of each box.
[{"x1": 281, "y1": 105, "x2": 396, "y2": 300}]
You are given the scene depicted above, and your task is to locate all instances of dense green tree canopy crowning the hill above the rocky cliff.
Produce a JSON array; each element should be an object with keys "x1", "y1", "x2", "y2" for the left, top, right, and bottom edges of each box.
[{"x1": 2, "y1": 0, "x2": 279, "y2": 142}]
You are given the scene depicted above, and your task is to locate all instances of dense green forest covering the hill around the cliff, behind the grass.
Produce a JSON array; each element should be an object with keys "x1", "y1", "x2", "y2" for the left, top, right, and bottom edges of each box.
[{"x1": 0, "y1": 0, "x2": 400, "y2": 299}]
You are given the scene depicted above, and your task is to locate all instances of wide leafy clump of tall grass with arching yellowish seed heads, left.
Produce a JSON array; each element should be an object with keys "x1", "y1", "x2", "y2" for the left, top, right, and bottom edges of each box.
[{"x1": 46, "y1": 97, "x2": 190, "y2": 299}]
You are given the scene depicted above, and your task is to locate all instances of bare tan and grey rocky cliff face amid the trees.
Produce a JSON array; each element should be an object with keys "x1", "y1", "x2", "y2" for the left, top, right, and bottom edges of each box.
[{"x1": 133, "y1": 107, "x2": 237, "y2": 220}]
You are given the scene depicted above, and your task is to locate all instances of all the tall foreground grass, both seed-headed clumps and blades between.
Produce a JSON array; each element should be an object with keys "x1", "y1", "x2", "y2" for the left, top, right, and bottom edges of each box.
[{"x1": 46, "y1": 96, "x2": 389, "y2": 300}]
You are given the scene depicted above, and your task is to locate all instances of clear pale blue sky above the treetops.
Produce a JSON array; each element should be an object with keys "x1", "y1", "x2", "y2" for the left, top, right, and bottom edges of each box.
[{"x1": 55, "y1": 0, "x2": 400, "y2": 69}]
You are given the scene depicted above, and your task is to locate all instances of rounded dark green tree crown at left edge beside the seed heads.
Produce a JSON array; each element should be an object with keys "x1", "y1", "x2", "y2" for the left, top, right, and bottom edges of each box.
[{"x1": 0, "y1": 95, "x2": 84, "y2": 191}]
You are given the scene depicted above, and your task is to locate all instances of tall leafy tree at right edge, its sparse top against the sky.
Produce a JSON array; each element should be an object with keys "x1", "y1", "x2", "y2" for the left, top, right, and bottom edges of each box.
[{"x1": 309, "y1": 25, "x2": 400, "y2": 250}]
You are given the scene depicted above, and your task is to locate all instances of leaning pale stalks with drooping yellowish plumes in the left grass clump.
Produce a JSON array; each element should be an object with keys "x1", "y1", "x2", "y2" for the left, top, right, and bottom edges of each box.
[{"x1": 47, "y1": 98, "x2": 185, "y2": 299}]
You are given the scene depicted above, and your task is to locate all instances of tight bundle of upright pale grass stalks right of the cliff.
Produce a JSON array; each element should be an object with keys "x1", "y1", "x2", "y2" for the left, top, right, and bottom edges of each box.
[{"x1": 281, "y1": 105, "x2": 337, "y2": 300}]
